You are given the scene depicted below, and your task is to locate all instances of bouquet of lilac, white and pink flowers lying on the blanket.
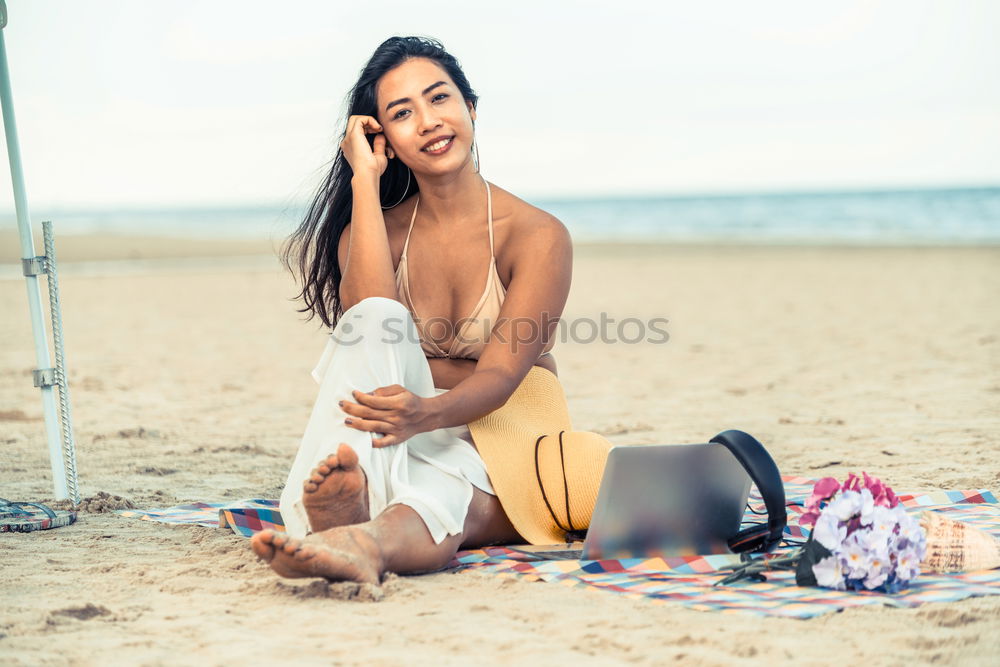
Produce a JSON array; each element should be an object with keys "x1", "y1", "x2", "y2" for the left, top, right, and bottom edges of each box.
[{"x1": 719, "y1": 472, "x2": 927, "y2": 593}]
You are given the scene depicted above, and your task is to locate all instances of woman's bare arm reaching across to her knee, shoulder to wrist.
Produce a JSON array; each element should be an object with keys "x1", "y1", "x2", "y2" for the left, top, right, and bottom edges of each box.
[{"x1": 426, "y1": 213, "x2": 573, "y2": 428}]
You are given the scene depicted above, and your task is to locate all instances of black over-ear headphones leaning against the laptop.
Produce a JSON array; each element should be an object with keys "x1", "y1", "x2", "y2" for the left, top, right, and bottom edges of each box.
[{"x1": 709, "y1": 429, "x2": 788, "y2": 553}]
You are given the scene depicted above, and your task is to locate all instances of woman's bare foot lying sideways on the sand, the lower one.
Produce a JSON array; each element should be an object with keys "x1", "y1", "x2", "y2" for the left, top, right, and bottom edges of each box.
[{"x1": 250, "y1": 526, "x2": 384, "y2": 584}]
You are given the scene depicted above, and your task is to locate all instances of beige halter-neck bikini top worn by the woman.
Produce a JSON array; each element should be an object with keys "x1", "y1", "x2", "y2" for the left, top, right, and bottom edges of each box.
[{"x1": 396, "y1": 182, "x2": 555, "y2": 360}]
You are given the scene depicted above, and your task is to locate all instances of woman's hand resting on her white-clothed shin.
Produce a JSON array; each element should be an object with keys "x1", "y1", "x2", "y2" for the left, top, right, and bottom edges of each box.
[{"x1": 339, "y1": 384, "x2": 433, "y2": 447}]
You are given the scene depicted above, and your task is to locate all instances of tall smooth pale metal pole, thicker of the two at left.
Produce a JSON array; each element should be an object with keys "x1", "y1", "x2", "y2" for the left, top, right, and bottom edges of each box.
[{"x1": 0, "y1": 0, "x2": 69, "y2": 500}]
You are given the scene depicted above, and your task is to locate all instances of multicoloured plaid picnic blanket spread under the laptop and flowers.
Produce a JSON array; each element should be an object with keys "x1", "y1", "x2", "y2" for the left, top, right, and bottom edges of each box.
[{"x1": 119, "y1": 476, "x2": 1000, "y2": 618}]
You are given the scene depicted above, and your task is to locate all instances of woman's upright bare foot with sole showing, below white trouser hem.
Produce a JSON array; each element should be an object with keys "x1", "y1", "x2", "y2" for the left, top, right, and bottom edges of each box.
[{"x1": 302, "y1": 443, "x2": 369, "y2": 533}]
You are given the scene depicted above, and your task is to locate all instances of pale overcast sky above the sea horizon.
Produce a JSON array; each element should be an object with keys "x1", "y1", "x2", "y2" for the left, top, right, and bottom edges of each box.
[{"x1": 0, "y1": 0, "x2": 1000, "y2": 210}]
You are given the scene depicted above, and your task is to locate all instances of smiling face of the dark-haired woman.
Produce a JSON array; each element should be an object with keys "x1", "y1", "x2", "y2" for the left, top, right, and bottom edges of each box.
[{"x1": 375, "y1": 58, "x2": 476, "y2": 174}]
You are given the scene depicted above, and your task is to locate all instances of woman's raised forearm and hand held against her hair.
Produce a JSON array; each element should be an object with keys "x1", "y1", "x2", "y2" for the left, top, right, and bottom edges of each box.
[{"x1": 337, "y1": 116, "x2": 398, "y2": 311}]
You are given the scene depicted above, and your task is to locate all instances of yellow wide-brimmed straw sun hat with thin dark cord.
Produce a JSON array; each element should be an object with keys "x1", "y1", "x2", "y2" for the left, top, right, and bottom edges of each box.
[{"x1": 469, "y1": 366, "x2": 611, "y2": 544}]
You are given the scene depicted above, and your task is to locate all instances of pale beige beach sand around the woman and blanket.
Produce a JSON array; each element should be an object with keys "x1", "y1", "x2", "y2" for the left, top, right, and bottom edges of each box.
[{"x1": 0, "y1": 238, "x2": 1000, "y2": 665}]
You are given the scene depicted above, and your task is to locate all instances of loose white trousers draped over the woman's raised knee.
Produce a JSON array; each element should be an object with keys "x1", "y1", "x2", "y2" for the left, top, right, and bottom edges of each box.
[{"x1": 280, "y1": 297, "x2": 496, "y2": 544}]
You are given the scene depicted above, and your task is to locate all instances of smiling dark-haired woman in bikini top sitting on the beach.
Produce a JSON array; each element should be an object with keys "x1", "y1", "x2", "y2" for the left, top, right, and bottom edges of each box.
[{"x1": 252, "y1": 37, "x2": 610, "y2": 582}]
